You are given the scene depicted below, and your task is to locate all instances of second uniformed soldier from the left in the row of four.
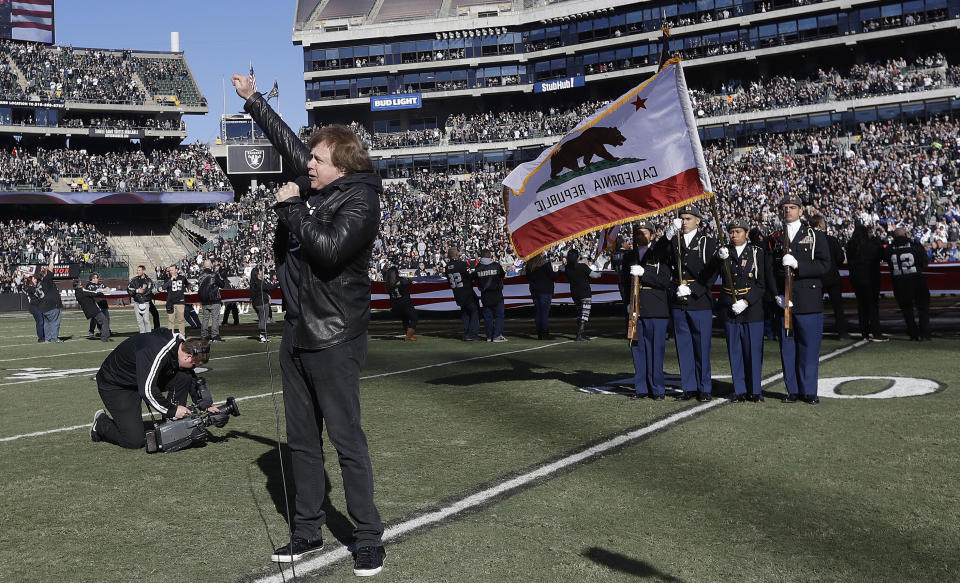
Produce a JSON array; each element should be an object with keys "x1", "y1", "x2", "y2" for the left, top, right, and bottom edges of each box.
[{"x1": 667, "y1": 205, "x2": 717, "y2": 402}]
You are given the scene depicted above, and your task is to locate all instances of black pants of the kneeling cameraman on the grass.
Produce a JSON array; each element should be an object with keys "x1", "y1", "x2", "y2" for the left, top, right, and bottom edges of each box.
[{"x1": 97, "y1": 375, "x2": 190, "y2": 449}]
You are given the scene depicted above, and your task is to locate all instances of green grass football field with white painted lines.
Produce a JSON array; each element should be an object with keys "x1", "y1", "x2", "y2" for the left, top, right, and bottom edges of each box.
[{"x1": 0, "y1": 310, "x2": 960, "y2": 583}]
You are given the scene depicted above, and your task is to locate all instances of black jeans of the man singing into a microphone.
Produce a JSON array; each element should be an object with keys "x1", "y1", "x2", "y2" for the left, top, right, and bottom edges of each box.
[{"x1": 280, "y1": 323, "x2": 383, "y2": 547}]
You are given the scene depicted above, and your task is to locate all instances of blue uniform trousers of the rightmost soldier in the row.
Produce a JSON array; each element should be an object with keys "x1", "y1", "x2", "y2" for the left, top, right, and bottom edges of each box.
[{"x1": 777, "y1": 312, "x2": 823, "y2": 397}]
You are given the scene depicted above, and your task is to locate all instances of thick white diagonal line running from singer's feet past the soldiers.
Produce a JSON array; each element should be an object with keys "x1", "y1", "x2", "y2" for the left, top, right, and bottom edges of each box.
[{"x1": 256, "y1": 340, "x2": 867, "y2": 583}]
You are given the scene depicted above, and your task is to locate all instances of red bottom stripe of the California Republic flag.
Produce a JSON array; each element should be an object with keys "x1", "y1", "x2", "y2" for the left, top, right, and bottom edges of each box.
[{"x1": 513, "y1": 168, "x2": 703, "y2": 256}]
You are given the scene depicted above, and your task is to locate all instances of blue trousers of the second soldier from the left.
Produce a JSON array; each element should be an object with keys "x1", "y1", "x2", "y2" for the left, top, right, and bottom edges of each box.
[{"x1": 671, "y1": 308, "x2": 713, "y2": 394}]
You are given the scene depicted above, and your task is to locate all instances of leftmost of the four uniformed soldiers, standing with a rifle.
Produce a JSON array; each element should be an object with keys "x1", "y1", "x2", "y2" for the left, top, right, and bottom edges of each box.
[{"x1": 623, "y1": 222, "x2": 672, "y2": 401}]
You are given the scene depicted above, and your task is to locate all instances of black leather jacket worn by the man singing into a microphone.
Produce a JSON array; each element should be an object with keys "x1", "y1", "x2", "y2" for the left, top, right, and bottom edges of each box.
[{"x1": 244, "y1": 93, "x2": 382, "y2": 350}]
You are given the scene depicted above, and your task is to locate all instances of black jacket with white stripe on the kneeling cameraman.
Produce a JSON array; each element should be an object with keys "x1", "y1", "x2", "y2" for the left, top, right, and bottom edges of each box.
[{"x1": 97, "y1": 328, "x2": 196, "y2": 418}]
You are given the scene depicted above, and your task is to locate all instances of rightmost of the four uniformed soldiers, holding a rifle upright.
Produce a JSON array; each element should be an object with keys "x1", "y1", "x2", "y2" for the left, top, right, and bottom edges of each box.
[{"x1": 769, "y1": 194, "x2": 830, "y2": 404}]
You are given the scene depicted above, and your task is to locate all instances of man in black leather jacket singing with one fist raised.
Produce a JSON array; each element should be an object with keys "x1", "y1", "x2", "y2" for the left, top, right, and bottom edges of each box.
[{"x1": 233, "y1": 70, "x2": 386, "y2": 577}]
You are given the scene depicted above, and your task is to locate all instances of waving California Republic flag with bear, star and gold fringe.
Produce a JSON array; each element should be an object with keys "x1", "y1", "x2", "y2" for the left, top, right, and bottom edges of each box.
[{"x1": 503, "y1": 59, "x2": 713, "y2": 258}]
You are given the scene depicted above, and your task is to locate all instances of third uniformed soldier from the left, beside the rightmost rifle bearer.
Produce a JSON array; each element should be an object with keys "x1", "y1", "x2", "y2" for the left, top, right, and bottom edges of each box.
[{"x1": 717, "y1": 220, "x2": 767, "y2": 403}]
